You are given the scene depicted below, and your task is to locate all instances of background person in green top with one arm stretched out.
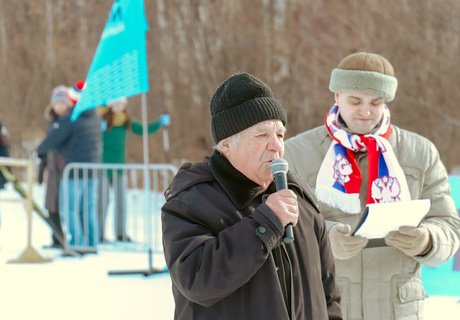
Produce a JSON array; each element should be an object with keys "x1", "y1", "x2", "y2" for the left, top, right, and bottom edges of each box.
[{"x1": 98, "y1": 97, "x2": 170, "y2": 242}]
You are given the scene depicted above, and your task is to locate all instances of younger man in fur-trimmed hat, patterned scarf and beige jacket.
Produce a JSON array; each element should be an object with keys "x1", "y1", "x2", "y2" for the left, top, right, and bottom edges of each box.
[{"x1": 285, "y1": 52, "x2": 460, "y2": 320}]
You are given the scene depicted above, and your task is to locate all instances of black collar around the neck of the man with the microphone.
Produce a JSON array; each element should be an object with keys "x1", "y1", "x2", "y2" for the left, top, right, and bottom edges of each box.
[{"x1": 208, "y1": 151, "x2": 273, "y2": 209}]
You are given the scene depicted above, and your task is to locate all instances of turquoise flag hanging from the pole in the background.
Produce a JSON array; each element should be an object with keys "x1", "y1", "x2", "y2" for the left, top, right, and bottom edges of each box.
[{"x1": 72, "y1": 0, "x2": 149, "y2": 121}]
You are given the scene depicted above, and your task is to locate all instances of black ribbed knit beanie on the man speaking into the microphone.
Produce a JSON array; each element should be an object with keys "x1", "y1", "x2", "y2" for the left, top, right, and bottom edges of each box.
[{"x1": 211, "y1": 73, "x2": 287, "y2": 143}]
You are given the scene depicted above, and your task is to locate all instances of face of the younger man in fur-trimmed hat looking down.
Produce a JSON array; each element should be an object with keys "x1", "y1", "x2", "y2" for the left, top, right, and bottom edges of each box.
[{"x1": 335, "y1": 92, "x2": 385, "y2": 134}]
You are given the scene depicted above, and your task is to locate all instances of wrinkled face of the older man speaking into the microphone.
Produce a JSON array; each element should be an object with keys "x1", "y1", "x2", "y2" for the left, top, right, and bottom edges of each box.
[{"x1": 220, "y1": 120, "x2": 286, "y2": 188}]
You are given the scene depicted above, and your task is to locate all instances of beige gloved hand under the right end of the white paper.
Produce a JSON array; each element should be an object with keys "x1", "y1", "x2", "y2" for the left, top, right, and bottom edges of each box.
[{"x1": 385, "y1": 225, "x2": 432, "y2": 257}]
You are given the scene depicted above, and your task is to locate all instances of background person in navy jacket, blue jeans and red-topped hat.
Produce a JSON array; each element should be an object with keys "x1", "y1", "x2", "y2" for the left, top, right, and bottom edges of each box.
[{"x1": 37, "y1": 81, "x2": 101, "y2": 250}]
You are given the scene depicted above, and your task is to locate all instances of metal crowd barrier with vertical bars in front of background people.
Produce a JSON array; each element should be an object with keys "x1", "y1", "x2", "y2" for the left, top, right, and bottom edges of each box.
[{"x1": 60, "y1": 163, "x2": 177, "y2": 264}]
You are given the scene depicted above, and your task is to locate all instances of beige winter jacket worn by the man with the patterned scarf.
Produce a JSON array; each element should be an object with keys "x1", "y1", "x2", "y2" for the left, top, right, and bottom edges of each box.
[{"x1": 285, "y1": 126, "x2": 460, "y2": 320}]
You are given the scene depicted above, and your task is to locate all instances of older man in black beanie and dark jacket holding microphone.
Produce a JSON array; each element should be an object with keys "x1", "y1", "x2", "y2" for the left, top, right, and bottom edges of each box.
[{"x1": 162, "y1": 73, "x2": 341, "y2": 320}]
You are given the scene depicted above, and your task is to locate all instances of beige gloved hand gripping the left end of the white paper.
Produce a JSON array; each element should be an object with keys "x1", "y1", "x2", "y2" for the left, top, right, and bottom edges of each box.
[{"x1": 329, "y1": 223, "x2": 368, "y2": 260}]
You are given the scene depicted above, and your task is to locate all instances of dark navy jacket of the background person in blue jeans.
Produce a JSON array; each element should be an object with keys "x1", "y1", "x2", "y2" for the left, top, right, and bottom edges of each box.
[{"x1": 37, "y1": 110, "x2": 101, "y2": 168}]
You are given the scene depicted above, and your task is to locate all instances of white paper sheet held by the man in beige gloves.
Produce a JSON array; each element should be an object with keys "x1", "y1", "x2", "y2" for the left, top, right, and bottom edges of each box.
[{"x1": 353, "y1": 199, "x2": 431, "y2": 239}]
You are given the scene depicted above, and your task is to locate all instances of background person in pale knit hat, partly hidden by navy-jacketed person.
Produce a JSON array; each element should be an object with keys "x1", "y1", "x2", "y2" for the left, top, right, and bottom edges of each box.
[{"x1": 38, "y1": 85, "x2": 71, "y2": 248}]
